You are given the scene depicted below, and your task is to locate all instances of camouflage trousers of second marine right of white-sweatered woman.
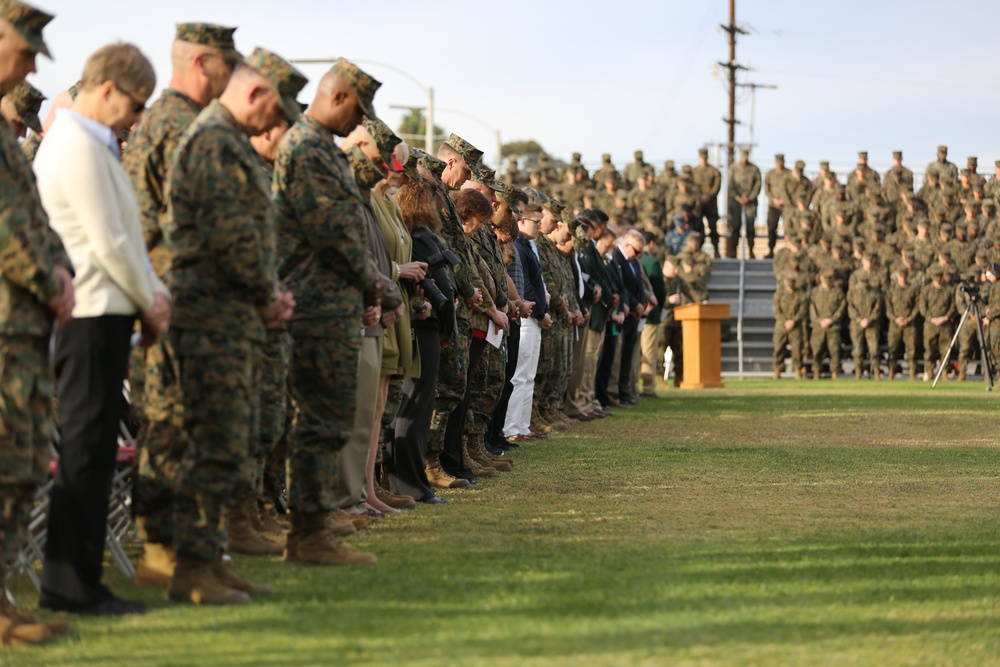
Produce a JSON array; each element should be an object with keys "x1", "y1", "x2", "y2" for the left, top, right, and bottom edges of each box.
[{"x1": 173, "y1": 329, "x2": 262, "y2": 561}]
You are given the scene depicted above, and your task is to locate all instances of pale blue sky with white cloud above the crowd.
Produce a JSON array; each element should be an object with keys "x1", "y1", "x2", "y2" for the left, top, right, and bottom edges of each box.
[{"x1": 23, "y1": 0, "x2": 1000, "y2": 180}]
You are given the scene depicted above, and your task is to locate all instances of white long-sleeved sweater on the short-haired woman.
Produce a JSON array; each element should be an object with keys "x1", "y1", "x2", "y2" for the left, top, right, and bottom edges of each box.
[{"x1": 33, "y1": 114, "x2": 168, "y2": 317}]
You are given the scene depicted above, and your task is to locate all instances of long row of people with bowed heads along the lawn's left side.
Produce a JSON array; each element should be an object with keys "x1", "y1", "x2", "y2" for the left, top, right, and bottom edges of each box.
[{"x1": 0, "y1": 0, "x2": 711, "y2": 644}]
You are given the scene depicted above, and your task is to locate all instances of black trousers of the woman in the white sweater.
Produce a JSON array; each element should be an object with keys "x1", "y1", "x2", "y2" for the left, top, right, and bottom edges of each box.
[{"x1": 41, "y1": 315, "x2": 135, "y2": 607}]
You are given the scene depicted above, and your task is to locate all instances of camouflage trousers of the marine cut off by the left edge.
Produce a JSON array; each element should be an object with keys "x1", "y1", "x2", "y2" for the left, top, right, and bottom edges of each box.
[{"x1": 0, "y1": 336, "x2": 55, "y2": 568}]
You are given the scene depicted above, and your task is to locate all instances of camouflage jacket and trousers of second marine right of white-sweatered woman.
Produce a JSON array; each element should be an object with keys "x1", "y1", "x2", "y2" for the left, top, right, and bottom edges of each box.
[{"x1": 168, "y1": 94, "x2": 277, "y2": 561}]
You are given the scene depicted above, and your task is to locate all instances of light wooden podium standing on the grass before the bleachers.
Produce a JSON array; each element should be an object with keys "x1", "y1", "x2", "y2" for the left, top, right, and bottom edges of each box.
[{"x1": 674, "y1": 303, "x2": 729, "y2": 389}]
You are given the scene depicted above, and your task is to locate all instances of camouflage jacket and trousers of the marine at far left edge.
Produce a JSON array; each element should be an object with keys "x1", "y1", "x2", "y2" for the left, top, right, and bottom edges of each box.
[{"x1": 0, "y1": 116, "x2": 69, "y2": 578}]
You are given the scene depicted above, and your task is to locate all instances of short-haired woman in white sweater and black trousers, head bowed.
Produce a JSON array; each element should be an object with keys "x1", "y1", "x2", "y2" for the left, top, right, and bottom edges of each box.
[{"x1": 34, "y1": 44, "x2": 170, "y2": 615}]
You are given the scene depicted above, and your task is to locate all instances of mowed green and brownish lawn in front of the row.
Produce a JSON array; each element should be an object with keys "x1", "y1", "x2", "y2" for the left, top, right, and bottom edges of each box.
[{"x1": 0, "y1": 380, "x2": 1000, "y2": 667}]
